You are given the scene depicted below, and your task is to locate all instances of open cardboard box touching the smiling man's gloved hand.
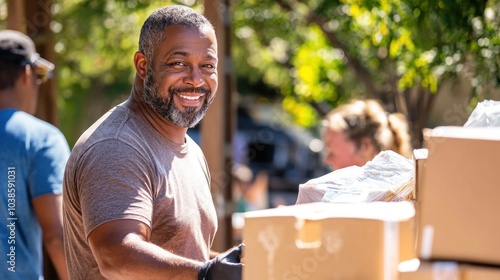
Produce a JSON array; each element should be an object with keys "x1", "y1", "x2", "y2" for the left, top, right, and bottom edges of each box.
[{"x1": 242, "y1": 202, "x2": 416, "y2": 280}]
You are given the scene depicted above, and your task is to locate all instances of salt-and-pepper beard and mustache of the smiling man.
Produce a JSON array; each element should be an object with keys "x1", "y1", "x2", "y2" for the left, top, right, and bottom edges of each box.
[{"x1": 143, "y1": 64, "x2": 213, "y2": 128}]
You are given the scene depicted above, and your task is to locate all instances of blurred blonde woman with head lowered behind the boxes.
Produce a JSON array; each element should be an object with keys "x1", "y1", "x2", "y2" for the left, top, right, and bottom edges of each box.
[{"x1": 322, "y1": 99, "x2": 413, "y2": 170}]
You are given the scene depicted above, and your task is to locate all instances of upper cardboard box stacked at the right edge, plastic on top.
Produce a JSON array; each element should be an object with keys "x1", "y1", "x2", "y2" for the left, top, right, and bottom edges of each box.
[{"x1": 416, "y1": 127, "x2": 500, "y2": 265}]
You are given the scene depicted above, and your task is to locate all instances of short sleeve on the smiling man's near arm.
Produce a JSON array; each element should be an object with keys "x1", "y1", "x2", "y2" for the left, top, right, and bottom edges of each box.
[{"x1": 76, "y1": 139, "x2": 154, "y2": 237}]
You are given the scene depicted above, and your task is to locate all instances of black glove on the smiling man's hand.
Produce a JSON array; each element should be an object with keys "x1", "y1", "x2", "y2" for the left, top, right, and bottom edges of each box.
[{"x1": 198, "y1": 244, "x2": 245, "y2": 280}]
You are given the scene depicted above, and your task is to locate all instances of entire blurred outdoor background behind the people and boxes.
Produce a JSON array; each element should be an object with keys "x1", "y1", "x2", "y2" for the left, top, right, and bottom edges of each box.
[{"x1": 0, "y1": 0, "x2": 500, "y2": 256}]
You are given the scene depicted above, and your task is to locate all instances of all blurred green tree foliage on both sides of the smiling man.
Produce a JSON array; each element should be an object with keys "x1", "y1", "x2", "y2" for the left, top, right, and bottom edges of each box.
[{"x1": 6, "y1": 0, "x2": 500, "y2": 147}]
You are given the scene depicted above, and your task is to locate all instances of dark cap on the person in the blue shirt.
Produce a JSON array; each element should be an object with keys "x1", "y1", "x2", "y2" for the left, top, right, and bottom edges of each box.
[{"x1": 0, "y1": 30, "x2": 55, "y2": 77}]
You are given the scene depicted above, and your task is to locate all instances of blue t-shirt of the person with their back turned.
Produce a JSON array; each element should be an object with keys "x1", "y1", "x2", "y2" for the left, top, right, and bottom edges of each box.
[{"x1": 0, "y1": 109, "x2": 69, "y2": 280}]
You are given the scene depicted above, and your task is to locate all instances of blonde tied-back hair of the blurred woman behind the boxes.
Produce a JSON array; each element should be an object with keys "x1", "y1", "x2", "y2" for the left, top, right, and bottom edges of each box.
[{"x1": 323, "y1": 99, "x2": 413, "y2": 158}]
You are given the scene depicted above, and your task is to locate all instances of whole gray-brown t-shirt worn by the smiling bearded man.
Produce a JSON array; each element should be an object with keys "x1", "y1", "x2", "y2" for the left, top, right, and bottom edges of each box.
[{"x1": 63, "y1": 105, "x2": 217, "y2": 279}]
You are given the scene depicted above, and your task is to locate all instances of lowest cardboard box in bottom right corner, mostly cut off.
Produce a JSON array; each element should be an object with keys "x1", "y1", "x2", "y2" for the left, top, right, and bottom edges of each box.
[{"x1": 399, "y1": 261, "x2": 500, "y2": 280}]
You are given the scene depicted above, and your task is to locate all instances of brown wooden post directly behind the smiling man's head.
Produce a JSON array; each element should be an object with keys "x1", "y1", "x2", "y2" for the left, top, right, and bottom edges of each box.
[{"x1": 201, "y1": 0, "x2": 236, "y2": 251}]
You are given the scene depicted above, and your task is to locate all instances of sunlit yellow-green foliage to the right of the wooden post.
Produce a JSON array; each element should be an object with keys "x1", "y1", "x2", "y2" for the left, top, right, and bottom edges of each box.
[{"x1": 233, "y1": 0, "x2": 500, "y2": 144}]
